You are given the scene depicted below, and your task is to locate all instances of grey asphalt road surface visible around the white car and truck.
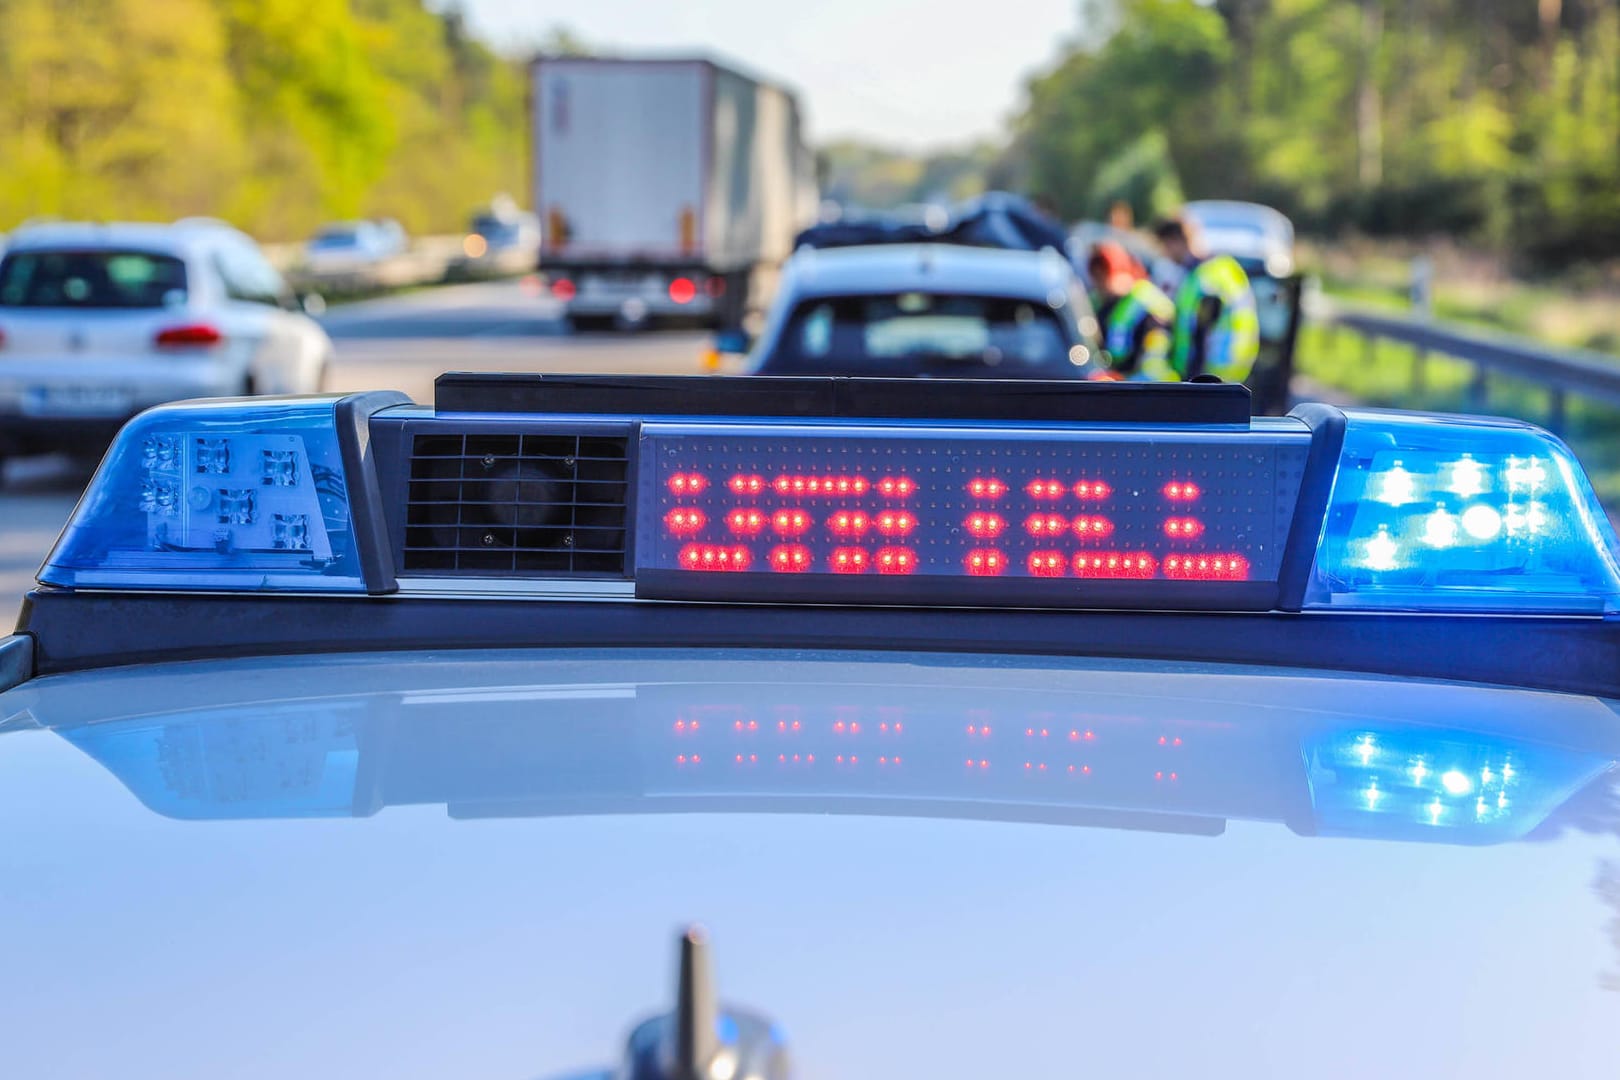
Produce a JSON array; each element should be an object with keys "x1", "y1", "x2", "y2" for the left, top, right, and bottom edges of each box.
[{"x1": 0, "y1": 282, "x2": 708, "y2": 633}]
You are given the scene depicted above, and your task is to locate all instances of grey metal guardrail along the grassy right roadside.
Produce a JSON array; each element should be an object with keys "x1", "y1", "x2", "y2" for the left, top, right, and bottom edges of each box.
[{"x1": 1306, "y1": 296, "x2": 1620, "y2": 431}]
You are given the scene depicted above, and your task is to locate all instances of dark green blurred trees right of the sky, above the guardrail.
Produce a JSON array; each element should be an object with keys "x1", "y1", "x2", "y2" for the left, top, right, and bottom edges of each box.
[{"x1": 1001, "y1": 0, "x2": 1620, "y2": 267}]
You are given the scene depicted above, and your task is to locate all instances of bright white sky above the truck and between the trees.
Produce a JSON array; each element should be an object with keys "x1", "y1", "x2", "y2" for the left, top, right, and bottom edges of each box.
[{"x1": 462, "y1": 0, "x2": 1079, "y2": 149}]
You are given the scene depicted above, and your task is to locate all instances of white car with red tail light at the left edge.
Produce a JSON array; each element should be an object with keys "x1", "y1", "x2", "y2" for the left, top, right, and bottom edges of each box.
[{"x1": 0, "y1": 220, "x2": 332, "y2": 472}]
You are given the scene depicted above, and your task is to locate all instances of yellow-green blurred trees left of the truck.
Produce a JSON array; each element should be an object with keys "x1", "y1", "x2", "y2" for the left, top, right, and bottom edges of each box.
[{"x1": 0, "y1": 0, "x2": 527, "y2": 238}]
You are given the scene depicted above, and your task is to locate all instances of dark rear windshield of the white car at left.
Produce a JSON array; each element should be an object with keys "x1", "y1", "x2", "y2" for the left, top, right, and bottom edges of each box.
[{"x1": 0, "y1": 251, "x2": 186, "y2": 308}]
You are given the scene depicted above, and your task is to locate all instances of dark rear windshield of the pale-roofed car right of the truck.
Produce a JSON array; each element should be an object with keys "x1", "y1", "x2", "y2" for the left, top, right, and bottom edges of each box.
[{"x1": 766, "y1": 293, "x2": 1077, "y2": 377}]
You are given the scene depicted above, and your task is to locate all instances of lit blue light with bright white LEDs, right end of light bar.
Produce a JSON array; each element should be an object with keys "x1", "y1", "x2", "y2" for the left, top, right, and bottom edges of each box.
[{"x1": 1306, "y1": 411, "x2": 1620, "y2": 615}]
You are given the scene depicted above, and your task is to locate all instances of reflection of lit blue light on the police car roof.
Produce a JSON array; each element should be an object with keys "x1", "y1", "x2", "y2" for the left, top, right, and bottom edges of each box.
[{"x1": 1304, "y1": 729, "x2": 1612, "y2": 844}]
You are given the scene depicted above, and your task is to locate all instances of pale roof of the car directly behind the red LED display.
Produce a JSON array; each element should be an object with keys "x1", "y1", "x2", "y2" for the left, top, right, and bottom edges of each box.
[{"x1": 786, "y1": 244, "x2": 1074, "y2": 303}]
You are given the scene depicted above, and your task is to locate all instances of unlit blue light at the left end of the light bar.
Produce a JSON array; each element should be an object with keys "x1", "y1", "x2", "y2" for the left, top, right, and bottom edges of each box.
[{"x1": 39, "y1": 397, "x2": 365, "y2": 593}]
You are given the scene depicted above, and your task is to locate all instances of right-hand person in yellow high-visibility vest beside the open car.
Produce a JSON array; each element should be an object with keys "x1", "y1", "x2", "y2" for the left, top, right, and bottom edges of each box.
[{"x1": 1153, "y1": 219, "x2": 1260, "y2": 382}]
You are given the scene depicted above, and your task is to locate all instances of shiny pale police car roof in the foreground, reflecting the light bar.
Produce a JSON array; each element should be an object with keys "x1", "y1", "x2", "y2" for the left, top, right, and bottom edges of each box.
[{"x1": 0, "y1": 647, "x2": 1620, "y2": 1080}]
